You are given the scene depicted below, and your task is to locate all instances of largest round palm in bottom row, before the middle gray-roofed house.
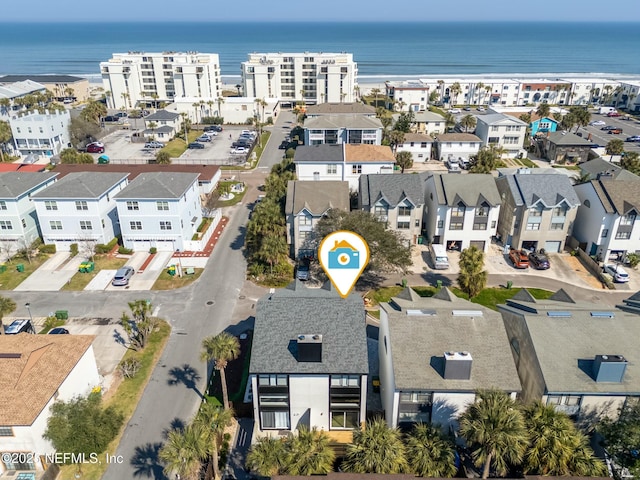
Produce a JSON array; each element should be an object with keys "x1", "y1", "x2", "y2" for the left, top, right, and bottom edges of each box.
[{"x1": 460, "y1": 390, "x2": 528, "y2": 479}]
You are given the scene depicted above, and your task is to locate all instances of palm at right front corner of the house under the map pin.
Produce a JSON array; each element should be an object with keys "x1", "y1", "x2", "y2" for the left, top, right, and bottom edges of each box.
[{"x1": 342, "y1": 418, "x2": 408, "y2": 474}]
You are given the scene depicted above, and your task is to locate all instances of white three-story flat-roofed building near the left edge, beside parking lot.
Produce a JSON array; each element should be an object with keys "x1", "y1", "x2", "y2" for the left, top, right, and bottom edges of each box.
[{"x1": 9, "y1": 110, "x2": 71, "y2": 157}]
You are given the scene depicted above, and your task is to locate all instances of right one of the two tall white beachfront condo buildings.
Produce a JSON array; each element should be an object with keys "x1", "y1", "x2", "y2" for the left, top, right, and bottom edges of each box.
[{"x1": 241, "y1": 52, "x2": 358, "y2": 105}]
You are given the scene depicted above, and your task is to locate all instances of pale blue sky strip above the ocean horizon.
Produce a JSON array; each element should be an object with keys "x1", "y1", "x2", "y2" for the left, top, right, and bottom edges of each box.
[{"x1": 0, "y1": 0, "x2": 640, "y2": 21}]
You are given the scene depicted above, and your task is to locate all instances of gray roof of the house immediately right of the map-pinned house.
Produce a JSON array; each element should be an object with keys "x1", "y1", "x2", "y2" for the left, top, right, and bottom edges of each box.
[{"x1": 381, "y1": 288, "x2": 520, "y2": 392}]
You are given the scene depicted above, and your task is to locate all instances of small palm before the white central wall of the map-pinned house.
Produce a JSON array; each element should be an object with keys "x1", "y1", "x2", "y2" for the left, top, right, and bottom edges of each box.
[{"x1": 285, "y1": 427, "x2": 336, "y2": 475}]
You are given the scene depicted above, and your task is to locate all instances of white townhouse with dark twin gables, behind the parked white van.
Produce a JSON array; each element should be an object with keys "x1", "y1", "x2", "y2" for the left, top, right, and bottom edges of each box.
[{"x1": 424, "y1": 173, "x2": 502, "y2": 252}]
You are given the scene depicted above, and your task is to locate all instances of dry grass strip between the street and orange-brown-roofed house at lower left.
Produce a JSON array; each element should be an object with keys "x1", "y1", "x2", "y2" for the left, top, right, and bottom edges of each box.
[{"x1": 58, "y1": 321, "x2": 171, "y2": 480}]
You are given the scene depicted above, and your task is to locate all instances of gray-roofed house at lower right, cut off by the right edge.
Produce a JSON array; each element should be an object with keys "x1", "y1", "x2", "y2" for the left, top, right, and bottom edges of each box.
[{"x1": 498, "y1": 290, "x2": 640, "y2": 419}]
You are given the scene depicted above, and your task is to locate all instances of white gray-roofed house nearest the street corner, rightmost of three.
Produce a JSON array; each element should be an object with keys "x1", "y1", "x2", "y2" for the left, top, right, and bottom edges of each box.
[{"x1": 114, "y1": 172, "x2": 202, "y2": 252}]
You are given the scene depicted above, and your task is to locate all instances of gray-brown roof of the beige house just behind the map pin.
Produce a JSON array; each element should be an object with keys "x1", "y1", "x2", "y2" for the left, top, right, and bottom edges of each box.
[{"x1": 284, "y1": 180, "x2": 349, "y2": 216}]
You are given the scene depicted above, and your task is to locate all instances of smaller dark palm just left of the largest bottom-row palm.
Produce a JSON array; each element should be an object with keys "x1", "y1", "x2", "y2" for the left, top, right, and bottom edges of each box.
[{"x1": 405, "y1": 424, "x2": 457, "y2": 477}]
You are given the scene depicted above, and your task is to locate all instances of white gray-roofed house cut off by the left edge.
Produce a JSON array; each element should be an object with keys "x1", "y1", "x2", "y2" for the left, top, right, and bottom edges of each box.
[{"x1": 0, "y1": 172, "x2": 57, "y2": 255}]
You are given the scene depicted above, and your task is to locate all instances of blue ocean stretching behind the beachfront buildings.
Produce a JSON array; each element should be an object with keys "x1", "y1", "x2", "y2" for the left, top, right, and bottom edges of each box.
[{"x1": 0, "y1": 21, "x2": 640, "y2": 83}]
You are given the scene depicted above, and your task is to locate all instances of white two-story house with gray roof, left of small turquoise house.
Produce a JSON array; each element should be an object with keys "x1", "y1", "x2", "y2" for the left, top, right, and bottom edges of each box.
[{"x1": 476, "y1": 113, "x2": 527, "y2": 158}]
